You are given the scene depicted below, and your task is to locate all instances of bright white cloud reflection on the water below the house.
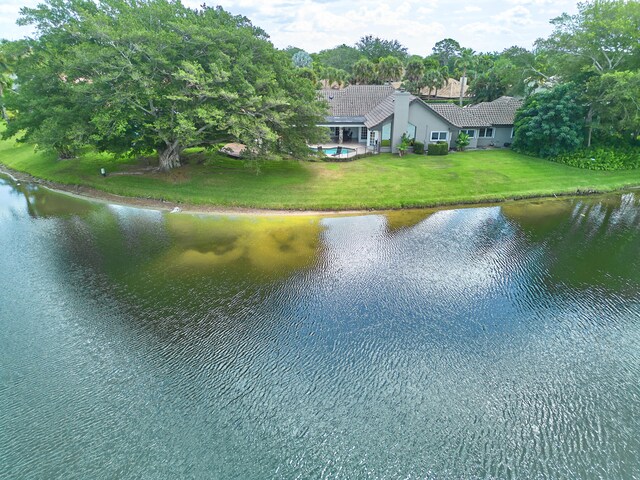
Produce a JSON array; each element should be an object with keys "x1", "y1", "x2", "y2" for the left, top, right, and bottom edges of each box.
[{"x1": 323, "y1": 207, "x2": 518, "y2": 304}]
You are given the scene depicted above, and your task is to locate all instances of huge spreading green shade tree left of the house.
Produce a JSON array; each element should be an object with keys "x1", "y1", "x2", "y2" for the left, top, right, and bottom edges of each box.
[{"x1": 5, "y1": 0, "x2": 324, "y2": 170}]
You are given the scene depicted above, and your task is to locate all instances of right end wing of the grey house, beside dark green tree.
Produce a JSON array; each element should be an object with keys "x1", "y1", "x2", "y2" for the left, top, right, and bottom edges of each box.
[{"x1": 465, "y1": 97, "x2": 522, "y2": 147}]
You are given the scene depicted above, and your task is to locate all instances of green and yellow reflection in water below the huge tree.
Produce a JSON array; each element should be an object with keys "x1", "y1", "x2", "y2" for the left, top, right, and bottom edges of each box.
[{"x1": 36, "y1": 204, "x2": 322, "y2": 329}]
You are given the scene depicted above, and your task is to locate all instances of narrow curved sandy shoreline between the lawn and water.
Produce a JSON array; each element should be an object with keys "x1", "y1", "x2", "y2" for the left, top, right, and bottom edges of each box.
[{"x1": 0, "y1": 164, "x2": 640, "y2": 216}]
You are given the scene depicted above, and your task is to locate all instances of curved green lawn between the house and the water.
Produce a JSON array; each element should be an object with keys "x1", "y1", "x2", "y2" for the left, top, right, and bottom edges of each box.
[{"x1": 0, "y1": 135, "x2": 640, "y2": 209}]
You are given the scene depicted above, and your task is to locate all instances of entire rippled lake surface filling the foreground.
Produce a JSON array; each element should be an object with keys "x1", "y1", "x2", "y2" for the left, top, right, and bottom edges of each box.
[{"x1": 0, "y1": 179, "x2": 640, "y2": 479}]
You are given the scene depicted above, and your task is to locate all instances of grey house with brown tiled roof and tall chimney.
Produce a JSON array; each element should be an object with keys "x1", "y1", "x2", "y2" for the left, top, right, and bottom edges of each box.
[{"x1": 320, "y1": 85, "x2": 515, "y2": 153}]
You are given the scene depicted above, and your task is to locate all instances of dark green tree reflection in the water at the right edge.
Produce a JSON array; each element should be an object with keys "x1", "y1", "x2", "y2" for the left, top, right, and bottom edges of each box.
[{"x1": 502, "y1": 193, "x2": 640, "y2": 293}]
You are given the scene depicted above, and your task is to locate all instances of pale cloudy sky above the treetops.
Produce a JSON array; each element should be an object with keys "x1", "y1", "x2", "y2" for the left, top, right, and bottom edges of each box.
[{"x1": 0, "y1": 0, "x2": 577, "y2": 56}]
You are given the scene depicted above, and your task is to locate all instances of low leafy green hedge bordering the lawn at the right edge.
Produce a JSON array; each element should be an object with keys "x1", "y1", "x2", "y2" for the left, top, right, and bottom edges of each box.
[{"x1": 551, "y1": 147, "x2": 640, "y2": 170}]
